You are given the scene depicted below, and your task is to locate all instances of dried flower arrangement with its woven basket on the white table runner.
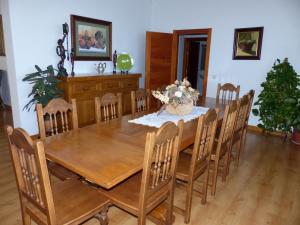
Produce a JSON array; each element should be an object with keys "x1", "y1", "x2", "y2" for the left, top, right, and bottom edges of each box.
[{"x1": 152, "y1": 79, "x2": 199, "y2": 115}]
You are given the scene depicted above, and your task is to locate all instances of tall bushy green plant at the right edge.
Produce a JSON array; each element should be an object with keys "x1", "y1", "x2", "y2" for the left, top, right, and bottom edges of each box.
[{"x1": 252, "y1": 59, "x2": 300, "y2": 142}]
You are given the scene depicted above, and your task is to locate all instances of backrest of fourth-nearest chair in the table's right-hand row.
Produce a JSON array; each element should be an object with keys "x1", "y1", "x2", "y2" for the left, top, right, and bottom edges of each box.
[{"x1": 234, "y1": 95, "x2": 249, "y2": 133}]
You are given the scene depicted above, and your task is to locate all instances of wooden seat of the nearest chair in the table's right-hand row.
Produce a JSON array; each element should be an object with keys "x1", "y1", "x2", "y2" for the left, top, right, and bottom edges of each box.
[{"x1": 98, "y1": 172, "x2": 169, "y2": 216}]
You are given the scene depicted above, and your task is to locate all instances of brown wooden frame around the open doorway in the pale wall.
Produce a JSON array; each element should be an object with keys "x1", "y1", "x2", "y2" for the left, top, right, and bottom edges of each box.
[{"x1": 171, "y1": 28, "x2": 212, "y2": 98}]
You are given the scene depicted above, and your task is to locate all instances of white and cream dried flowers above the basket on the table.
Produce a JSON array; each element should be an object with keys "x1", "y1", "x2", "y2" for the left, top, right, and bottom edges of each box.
[{"x1": 152, "y1": 79, "x2": 199, "y2": 114}]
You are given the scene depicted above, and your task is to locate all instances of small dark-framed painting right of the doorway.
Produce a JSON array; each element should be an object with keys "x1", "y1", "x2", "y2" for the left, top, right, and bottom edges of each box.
[{"x1": 233, "y1": 27, "x2": 264, "y2": 60}]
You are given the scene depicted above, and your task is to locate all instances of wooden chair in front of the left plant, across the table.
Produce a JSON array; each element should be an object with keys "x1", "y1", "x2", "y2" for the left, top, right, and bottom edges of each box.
[{"x1": 36, "y1": 98, "x2": 78, "y2": 180}]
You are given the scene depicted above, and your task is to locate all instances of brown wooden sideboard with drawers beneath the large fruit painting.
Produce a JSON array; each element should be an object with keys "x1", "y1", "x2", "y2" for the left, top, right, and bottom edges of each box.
[{"x1": 59, "y1": 74, "x2": 141, "y2": 127}]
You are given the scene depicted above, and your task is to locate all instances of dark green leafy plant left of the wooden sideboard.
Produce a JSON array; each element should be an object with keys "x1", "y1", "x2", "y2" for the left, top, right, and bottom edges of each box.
[{"x1": 23, "y1": 65, "x2": 63, "y2": 111}]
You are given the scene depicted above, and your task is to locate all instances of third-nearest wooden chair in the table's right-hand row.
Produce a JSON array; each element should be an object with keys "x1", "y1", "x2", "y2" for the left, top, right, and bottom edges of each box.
[{"x1": 211, "y1": 100, "x2": 237, "y2": 195}]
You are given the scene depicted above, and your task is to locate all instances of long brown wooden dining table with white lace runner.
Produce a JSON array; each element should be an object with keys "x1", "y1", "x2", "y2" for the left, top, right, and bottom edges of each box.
[{"x1": 44, "y1": 98, "x2": 224, "y2": 189}]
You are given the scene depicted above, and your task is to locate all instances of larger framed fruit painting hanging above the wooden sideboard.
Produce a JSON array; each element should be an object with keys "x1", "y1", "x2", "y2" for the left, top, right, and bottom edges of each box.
[{"x1": 71, "y1": 15, "x2": 112, "y2": 61}]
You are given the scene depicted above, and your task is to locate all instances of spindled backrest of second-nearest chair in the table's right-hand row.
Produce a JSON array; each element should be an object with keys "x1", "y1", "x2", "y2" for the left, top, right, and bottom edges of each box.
[{"x1": 189, "y1": 109, "x2": 219, "y2": 176}]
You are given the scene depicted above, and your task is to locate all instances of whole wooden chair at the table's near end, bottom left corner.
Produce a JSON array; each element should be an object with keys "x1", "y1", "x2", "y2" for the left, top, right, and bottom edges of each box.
[{"x1": 6, "y1": 126, "x2": 109, "y2": 225}]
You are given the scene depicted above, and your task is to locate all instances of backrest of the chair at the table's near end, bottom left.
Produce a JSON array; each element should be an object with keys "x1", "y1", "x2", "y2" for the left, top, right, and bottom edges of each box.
[{"x1": 6, "y1": 126, "x2": 56, "y2": 224}]
